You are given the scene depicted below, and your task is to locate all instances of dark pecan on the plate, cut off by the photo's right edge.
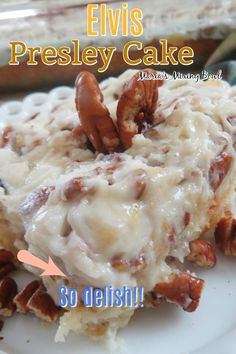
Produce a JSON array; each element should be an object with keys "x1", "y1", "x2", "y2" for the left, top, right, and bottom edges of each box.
[{"x1": 215, "y1": 211, "x2": 236, "y2": 257}]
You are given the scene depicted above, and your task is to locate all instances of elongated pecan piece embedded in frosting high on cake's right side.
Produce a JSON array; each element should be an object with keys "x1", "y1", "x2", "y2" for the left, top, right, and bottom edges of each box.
[{"x1": 209, "y1": 152, "x2": 233, "y2": 192}]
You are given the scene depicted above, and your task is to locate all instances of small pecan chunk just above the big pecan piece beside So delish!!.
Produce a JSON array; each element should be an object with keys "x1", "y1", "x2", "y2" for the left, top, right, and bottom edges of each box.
[{"x1": 187, "y1": 240, "x2": 216, "y2": 268}]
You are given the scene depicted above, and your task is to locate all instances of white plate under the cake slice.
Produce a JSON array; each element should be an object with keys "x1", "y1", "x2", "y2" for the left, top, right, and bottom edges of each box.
[{"x1": 0, "y1": 249, "x2": 236, "y2": 354}]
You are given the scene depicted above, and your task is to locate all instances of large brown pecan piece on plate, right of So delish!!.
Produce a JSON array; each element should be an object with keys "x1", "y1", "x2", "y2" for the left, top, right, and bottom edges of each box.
[{"x1": 152, "y1": 273, "x2": 204, "y2": 312}]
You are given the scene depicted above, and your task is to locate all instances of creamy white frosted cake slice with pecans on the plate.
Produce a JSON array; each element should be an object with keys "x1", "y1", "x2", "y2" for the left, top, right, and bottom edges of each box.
[{"x1": 0, "y1": 69, "x2": 236, "y2": 340}]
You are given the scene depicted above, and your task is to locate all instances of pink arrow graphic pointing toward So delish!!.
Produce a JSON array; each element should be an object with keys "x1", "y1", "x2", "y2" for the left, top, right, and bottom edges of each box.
[{"x1": 17, "y1": 250, "x2": 66, "y2": 277}]
